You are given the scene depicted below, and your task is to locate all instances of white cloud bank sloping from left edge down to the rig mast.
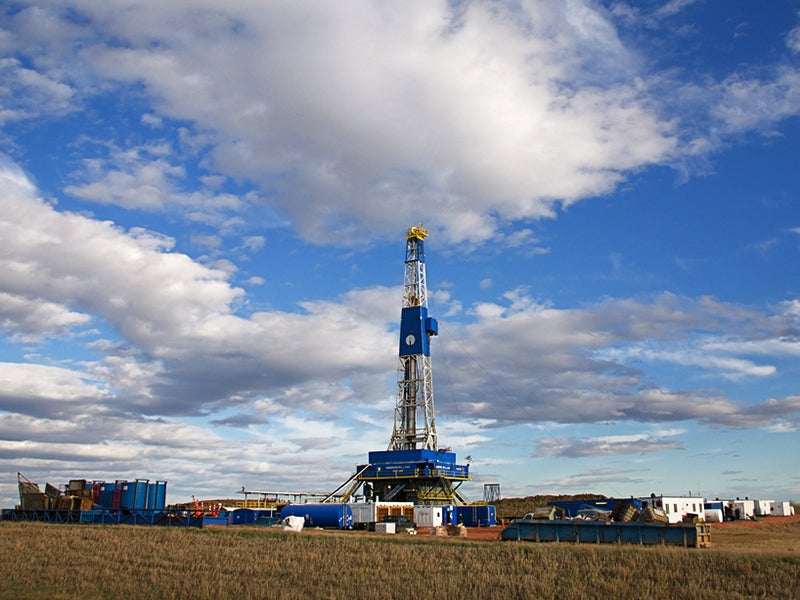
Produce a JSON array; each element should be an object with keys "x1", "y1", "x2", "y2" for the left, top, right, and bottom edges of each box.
[{"x1": 0, "y1": 164, "x2": 399, "y2": 414}]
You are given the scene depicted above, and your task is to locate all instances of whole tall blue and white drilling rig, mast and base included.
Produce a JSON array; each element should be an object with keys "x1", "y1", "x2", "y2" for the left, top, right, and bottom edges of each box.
[{"x1": 337, "y1": 223, "x2": 470, "y2": 505}]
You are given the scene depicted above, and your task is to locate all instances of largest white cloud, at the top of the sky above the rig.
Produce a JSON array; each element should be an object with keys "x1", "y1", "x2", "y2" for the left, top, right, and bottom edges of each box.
[{"x1": 0, "y1": 0, "x2": 676, "y2": 243}]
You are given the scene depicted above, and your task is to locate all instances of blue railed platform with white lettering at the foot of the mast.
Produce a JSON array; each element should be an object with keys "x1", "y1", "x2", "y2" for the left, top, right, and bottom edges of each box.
[{"x1": 357, "y1": 450, "x2": 469, "y2": 479}]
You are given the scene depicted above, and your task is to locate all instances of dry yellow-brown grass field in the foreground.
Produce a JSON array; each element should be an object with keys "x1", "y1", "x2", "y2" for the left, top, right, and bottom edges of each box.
[{"x1": 0, "y1": 520, "x2": 800, "y2": 600}]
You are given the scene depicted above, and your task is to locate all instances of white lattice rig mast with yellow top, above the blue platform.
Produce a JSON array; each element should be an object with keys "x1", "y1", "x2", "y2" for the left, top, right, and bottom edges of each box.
[{"x1": 389, "y1": 224, "x2": 438, "y2": 450}]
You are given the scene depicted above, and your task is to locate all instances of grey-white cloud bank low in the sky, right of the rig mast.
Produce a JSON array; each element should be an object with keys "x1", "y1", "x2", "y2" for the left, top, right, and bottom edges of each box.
[{"x1": 439, "y1": 293, "x2": 798, "y2": 427}]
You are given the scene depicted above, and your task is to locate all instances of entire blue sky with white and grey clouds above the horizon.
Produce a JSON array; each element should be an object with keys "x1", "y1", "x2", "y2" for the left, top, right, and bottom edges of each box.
[{"x1": 0, "y1": 0, "x2": 800, "y2": 507}]
